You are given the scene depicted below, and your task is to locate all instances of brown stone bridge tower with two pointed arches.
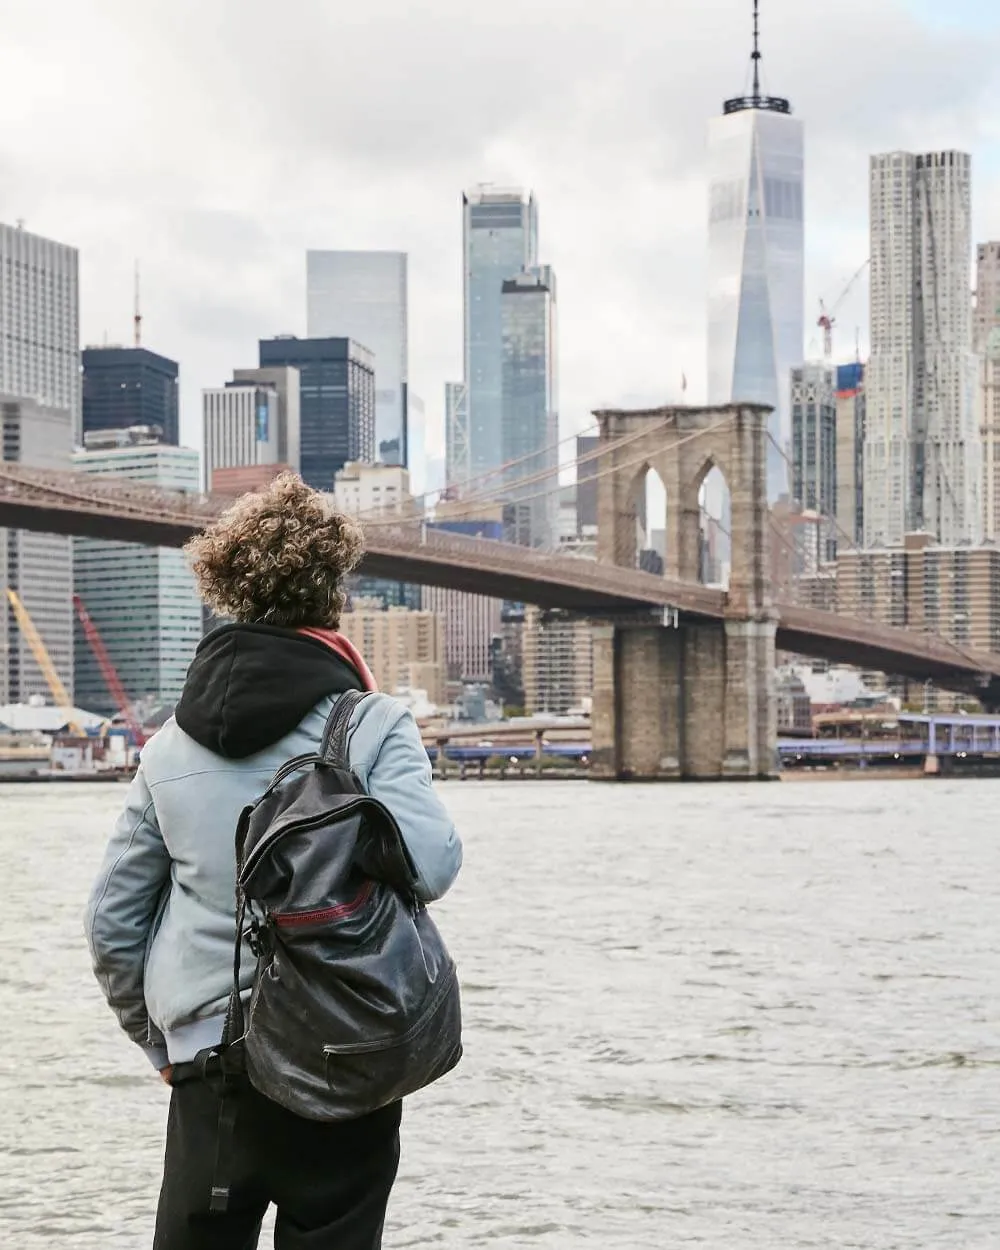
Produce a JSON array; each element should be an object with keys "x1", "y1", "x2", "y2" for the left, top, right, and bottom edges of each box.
[{"x1": 591, "y1": 404, "x2": 776, "y2": 780}]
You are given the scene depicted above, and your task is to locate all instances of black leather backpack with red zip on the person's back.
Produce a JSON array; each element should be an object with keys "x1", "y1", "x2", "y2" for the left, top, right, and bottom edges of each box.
[{"x1": 220, "y1": 691, "x2": 461, "y2": 1120}]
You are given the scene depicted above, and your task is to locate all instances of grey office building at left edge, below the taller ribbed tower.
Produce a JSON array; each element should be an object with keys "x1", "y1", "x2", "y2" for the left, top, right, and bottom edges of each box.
[{"x1": 0, "y1": 400, "x2": 73, "y2": 704}]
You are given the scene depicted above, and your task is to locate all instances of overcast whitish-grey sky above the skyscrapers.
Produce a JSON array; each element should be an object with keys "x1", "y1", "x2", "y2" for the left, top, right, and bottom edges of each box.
[{"x1": 0, "y1": 0, "x2": 1000, "y2": 470}]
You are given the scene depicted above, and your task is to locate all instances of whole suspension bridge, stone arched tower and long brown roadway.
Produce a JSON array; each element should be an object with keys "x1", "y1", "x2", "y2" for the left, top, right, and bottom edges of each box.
[{"x1": 0, "y1": 405, "x2": 1000, "y2": 778}]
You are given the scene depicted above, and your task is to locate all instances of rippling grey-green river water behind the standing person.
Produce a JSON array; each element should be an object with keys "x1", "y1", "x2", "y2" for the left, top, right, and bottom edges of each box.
[{"x1": 0, "y1": 780, "x2": 1000, "y2": 1250}]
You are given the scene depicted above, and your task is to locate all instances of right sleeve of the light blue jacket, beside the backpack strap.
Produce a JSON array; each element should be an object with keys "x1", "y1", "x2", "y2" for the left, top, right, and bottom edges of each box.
[{"x1": 351, "y1": 699, "x2": 461, "y2": 903}]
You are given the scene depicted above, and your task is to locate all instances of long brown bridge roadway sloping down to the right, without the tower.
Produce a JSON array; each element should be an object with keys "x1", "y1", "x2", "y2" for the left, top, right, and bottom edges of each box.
[{"x1": 0, "y1": 464, "x2": 1000, "y2": 706}]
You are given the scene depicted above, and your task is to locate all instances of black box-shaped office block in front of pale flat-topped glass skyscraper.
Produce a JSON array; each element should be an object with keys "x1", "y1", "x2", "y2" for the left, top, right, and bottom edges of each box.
[{"x1": 259, "y1": 335, "x2": 375, "y2": 490}]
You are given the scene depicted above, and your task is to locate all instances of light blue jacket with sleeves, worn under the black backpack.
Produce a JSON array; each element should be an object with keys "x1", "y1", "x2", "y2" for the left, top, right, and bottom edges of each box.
[{"x1": 86, "y1": 695, "x2": 461, "y2": 1069}]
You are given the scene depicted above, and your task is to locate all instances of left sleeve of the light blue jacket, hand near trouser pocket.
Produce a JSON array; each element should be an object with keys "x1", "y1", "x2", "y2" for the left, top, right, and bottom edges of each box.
[{"x1": 86, "y1": 764, "x2": 170, "y2": 1069}]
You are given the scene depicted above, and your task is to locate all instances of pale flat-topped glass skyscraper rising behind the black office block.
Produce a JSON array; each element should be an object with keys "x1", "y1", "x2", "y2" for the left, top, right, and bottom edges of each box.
[{"x1": 306, "y1": 251, "x2": 410, "y2": 468}]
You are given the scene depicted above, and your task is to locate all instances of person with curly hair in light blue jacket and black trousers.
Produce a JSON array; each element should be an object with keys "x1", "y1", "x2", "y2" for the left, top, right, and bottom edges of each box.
[{"x1": 86, "y1": 474, "x2": 461, "y2": 1250}]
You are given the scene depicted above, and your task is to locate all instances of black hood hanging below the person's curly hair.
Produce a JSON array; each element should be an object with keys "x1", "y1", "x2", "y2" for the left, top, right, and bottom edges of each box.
[{"x1": 174, "y1": 625, "x2": 364, "y2": 760}]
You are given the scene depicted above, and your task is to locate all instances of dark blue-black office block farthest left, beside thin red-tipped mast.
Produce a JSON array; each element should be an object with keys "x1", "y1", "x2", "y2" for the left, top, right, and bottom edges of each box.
[{"x1": 81, "y1": 348, "x2": 180, "y2": 446}]
